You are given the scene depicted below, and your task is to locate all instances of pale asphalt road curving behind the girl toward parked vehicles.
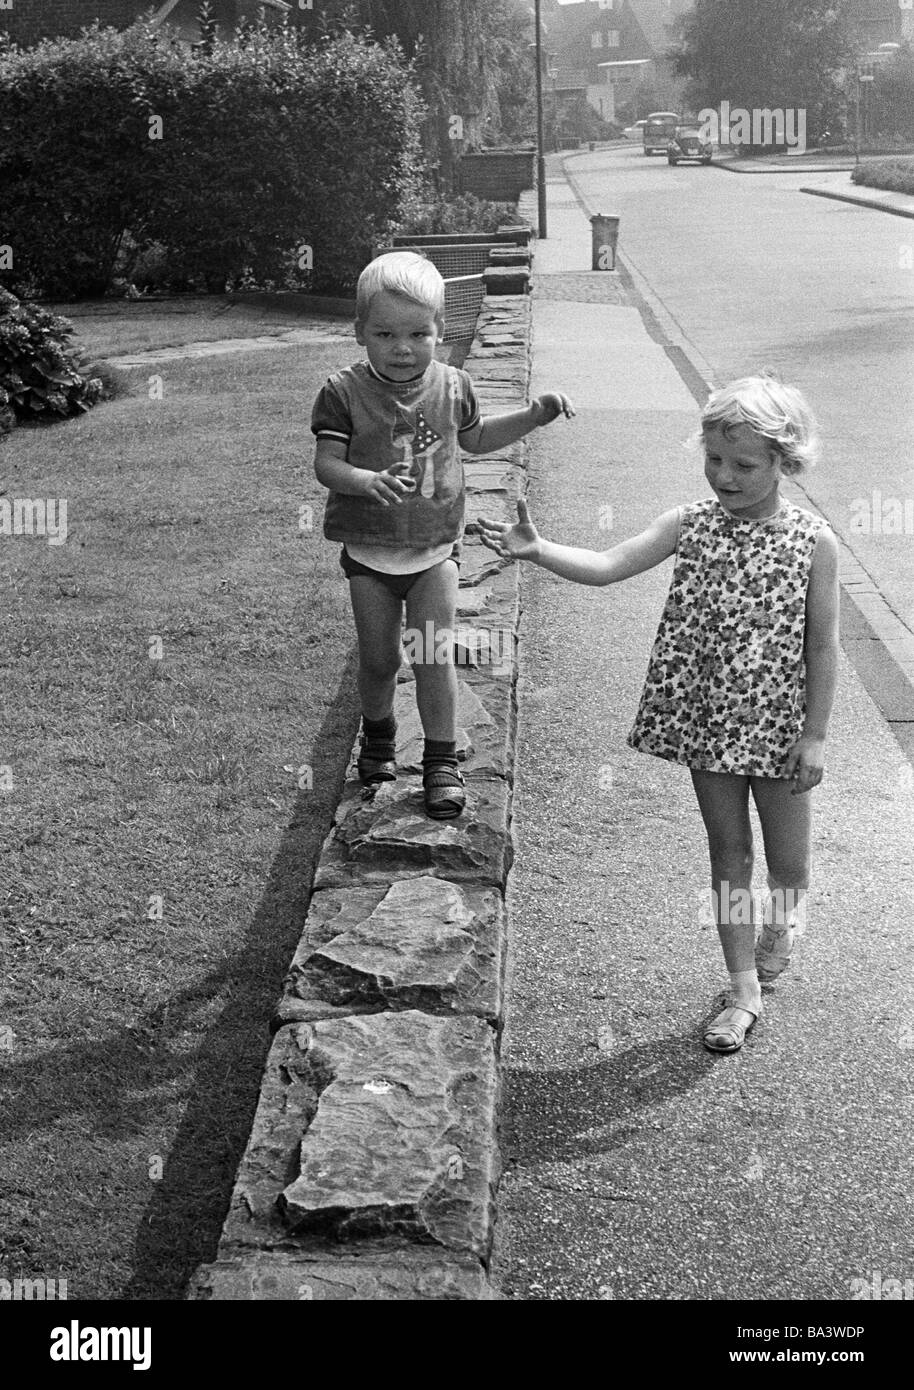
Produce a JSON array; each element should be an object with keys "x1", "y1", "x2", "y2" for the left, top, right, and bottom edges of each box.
[{"x1": 568, "y1": 146, "x2": 914, "y2": 631}]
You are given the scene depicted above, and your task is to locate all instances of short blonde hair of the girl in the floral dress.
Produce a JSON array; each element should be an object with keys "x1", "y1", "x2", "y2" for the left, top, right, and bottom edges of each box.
[{"x1": 695, "y1": 373, "x2": 820, "y2": 473}]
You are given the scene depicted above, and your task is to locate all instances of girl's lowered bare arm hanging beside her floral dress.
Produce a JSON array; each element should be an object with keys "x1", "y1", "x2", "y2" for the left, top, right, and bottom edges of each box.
[{"x1": 786, "y1": 527, "x2": 838, "y2": 795}]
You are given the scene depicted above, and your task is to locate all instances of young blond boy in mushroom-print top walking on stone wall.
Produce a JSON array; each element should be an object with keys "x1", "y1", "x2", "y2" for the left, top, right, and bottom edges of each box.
[{"x1": 311, "y1": 252, "x2": 574, "y2": 820}]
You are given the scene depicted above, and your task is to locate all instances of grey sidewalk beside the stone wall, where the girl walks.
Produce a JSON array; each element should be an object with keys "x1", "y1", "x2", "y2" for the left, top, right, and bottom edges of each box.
[{"x1": 492, "y1": 165, "x2": 914, "y2": 1301}]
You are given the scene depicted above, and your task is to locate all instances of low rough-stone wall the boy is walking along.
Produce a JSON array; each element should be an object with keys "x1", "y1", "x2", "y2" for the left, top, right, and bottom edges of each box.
[{"x1": 189, "y1": 296, "x2": 531, "y2": 1300}]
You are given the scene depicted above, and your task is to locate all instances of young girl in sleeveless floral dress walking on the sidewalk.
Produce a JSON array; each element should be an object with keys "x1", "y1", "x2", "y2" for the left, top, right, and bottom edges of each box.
[{"x1": 479, "y1": 375, "x2": 838, "y2": 1052}]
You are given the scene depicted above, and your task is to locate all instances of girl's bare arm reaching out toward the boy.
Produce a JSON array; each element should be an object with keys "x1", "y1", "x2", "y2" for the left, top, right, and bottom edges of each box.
[{"x1": 476, "y1": 502, "x2": 679, "y2": 584}]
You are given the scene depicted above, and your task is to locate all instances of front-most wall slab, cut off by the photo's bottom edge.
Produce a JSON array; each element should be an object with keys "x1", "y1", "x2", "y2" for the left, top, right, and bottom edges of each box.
[{"x1": 188, "y1": 1252, "x2": 495, "y2": 1302}]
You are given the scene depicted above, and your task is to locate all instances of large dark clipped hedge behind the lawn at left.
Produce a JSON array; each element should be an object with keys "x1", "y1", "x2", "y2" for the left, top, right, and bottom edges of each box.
[{"x1": 0, "y1": 24, "x2": 424, "y2": 299}]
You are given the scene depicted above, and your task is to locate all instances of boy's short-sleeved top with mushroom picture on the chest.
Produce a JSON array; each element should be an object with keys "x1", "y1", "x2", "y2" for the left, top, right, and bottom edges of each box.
[{"x1": 311, "y1": 360, "x2": 479, "y2": 549}]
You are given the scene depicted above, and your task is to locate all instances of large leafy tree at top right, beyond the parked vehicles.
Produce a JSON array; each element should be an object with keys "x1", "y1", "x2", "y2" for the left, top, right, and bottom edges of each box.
[{"x1": 672, "y1": 0, "x2": 853, "y2": 138}]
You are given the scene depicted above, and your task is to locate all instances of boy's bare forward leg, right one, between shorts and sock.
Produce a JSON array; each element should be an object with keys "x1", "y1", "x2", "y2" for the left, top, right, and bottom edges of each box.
[{"x1": 406, "y1": 560, "x2": 458, "y2": 742}]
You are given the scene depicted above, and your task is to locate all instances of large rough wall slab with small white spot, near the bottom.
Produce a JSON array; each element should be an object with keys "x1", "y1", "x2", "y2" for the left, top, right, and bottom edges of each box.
[{"x1": 218, "y1": 1011, "x2": 497, "y2": 1261}]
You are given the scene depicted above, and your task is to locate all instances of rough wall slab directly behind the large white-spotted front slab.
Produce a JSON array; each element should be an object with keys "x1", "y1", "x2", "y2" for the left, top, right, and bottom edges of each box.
[{"x1": 276, "y1": 876, "x2": 504, "y2": 1024}]
